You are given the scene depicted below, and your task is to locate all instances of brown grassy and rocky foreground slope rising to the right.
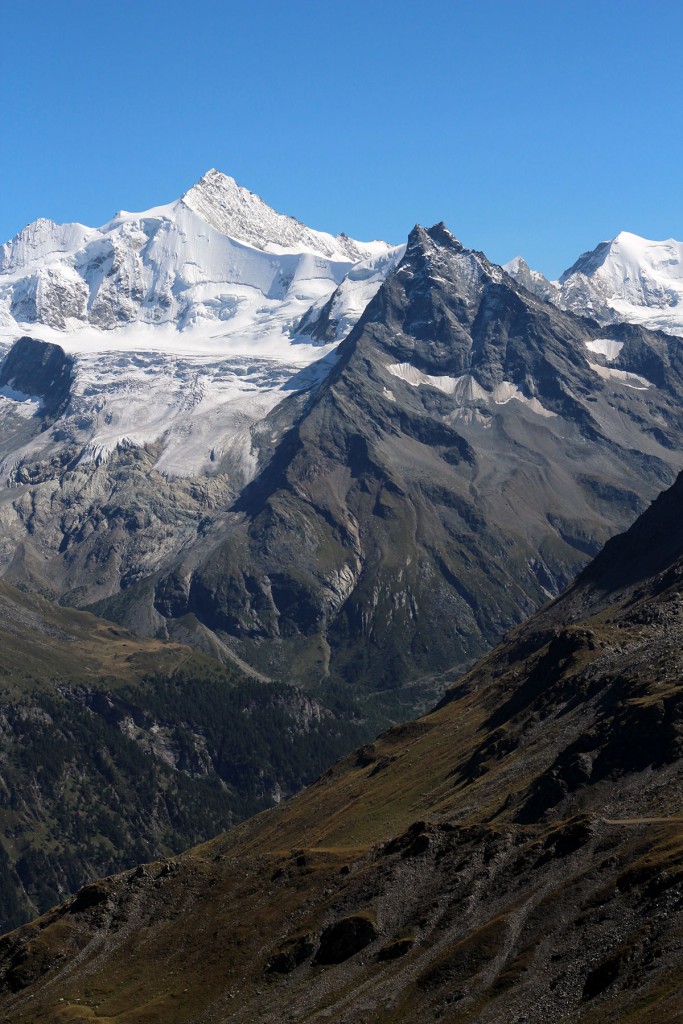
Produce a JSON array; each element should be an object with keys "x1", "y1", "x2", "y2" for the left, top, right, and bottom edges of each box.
[{"x1": 0, "y1": 434, "x2": 683, "y2": 1024}]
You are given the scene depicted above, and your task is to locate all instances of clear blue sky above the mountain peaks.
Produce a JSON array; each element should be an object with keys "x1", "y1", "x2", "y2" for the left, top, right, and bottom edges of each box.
[{"x1": 0, "y1": 0, "x2": 683, "y2": 276}]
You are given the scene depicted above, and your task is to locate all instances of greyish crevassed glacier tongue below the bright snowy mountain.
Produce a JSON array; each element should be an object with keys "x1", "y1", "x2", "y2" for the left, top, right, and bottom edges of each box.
[{"x1": 69, "y1": 352, "x2": 329, "y2": 483}]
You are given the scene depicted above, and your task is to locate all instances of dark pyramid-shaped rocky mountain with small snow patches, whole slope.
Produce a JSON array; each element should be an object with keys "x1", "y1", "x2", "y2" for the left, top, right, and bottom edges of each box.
[{"x1": 103, "y1": 225, "x2": 680, "y2": 685}]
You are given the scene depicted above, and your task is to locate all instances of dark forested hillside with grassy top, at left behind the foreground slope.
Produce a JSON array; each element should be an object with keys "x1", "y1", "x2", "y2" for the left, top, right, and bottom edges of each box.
[{"x1": 0, "y1": 583, "x2": 389, "y2": 931}]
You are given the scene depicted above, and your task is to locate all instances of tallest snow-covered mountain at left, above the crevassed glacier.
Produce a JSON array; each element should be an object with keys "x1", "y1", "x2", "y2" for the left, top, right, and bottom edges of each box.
[{"x1": 0, "y1": 170, "x2": 392, "y2": 347}]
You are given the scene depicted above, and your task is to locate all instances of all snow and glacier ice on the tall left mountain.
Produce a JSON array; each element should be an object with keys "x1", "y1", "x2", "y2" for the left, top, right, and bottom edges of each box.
[{"x1": 0, "y1": 170, "x2": 402, "y2": 480}]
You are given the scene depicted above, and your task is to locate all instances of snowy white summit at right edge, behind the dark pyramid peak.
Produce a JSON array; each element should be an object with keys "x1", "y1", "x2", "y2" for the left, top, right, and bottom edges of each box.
[{"x1": 504, "y1": 231, "x2": 683, "y2": 336}]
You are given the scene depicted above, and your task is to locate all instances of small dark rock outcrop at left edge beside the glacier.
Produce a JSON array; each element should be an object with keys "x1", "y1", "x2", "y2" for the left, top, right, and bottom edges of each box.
[{"x1": 0, "y1": 337, "x2": 74, "y2": 422}]
